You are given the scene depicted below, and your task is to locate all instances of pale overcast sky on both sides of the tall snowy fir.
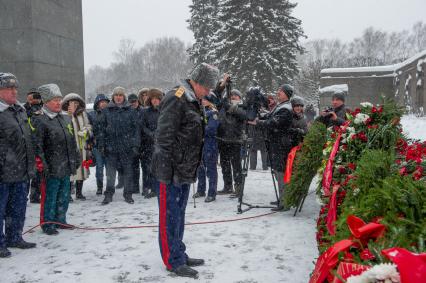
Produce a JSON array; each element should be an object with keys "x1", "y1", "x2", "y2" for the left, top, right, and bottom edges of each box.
[{"x1": 83, "y1": 0, "x2": 426, "y2": 70}]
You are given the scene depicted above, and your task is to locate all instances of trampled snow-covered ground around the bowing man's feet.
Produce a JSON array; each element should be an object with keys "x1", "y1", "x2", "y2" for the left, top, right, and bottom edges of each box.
[{"x1": 0, "y1": 170, "x2": 319, "y2": 283}]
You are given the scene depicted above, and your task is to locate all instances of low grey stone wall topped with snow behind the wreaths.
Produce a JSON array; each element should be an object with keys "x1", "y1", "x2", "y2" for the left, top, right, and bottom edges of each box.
[{"x1": 320, "y1": 50, "x2": 426, "y2": 115}]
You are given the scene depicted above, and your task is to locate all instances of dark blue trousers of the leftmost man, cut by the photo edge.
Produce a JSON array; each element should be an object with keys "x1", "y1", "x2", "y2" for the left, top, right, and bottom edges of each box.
[{"x1": 0, "y1": 182, "x2": 28, "y2": 248}]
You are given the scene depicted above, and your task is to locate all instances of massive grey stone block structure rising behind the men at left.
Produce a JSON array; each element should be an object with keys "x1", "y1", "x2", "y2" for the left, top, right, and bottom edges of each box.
[{"x1": 0, "y1": 0, "x2": 85, "y2": 101}]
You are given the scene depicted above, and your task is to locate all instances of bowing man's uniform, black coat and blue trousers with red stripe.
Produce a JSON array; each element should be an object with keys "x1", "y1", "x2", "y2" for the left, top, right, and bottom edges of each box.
[{"x1": 152, "y1": 81, "x2": 204, "y2": 270}]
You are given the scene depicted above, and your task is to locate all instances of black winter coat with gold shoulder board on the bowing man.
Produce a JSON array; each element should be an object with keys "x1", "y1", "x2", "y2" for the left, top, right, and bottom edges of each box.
[{"x1": 151, "y1": 81, "x2": 205, "y2": 185}]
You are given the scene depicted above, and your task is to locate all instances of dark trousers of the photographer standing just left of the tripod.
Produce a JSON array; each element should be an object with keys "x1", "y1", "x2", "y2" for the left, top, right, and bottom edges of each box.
[{"x1": 218, "y1": 143, "x2": 242, "y2": 191}]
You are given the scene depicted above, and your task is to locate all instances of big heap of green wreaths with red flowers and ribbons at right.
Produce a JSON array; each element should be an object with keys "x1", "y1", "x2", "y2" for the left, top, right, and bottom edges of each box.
[{"x1": 310, "y1": 102, "x2": 426, "y2": 283}]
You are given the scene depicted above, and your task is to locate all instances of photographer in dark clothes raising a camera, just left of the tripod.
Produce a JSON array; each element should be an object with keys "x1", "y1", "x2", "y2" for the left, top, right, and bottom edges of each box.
[{"x1": 217, "y1": 89, "x2": 247, "y2": 197}]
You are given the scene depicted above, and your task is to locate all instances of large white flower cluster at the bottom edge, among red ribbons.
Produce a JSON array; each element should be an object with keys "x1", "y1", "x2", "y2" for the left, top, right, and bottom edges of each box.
[{"x1": 346, "y1": 263, "x2": 401, "y2": 283}]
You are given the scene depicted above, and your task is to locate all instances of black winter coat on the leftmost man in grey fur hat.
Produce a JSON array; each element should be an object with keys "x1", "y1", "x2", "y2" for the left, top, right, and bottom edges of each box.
[{"x1": 0, "y1": 104, "x2": 35, "y2": 183}]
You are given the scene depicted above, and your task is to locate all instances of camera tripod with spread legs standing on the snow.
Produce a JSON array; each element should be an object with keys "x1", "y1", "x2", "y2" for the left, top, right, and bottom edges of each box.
[{"x1": 237, "y1": 127, "x2": 280, "y2": 214}]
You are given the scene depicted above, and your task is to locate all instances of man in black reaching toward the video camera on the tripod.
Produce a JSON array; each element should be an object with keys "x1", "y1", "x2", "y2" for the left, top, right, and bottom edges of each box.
[{"x1": 249, "y1": 84, "x2": 294, "y2": 211}]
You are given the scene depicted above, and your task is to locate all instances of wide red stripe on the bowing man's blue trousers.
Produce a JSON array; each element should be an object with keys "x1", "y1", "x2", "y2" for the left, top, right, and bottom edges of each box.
[{"x1": 159, "y1": 183, "x2": 172, "y2": 269}]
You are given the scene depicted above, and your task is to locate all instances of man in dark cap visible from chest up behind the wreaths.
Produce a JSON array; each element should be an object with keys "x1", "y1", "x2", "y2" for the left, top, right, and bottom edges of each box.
[{"x1": 317, "y1": 92, "x2": 347, "y2": 128}]
